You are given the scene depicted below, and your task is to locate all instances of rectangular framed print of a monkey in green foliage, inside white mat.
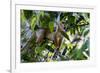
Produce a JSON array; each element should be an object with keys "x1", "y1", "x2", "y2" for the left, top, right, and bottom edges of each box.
[{"x1": 20, "y1": 10, "x2": 90, "y2": 63}]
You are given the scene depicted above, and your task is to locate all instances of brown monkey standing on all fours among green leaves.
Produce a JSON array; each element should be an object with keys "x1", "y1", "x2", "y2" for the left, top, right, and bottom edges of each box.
[{"x1": 36, "y1": 24, "x2": 64, "y2": 48}]
